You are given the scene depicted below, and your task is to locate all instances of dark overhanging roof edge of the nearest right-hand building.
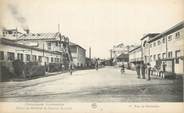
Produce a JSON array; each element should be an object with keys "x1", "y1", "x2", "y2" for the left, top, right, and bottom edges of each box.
[{"x1": 148, "y1": 21, "x2": 184, "y2": 42}]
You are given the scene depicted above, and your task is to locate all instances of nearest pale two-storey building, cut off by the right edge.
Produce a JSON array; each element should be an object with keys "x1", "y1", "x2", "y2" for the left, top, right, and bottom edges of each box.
[{"x1": 148, "y1": 21, "x2": 184, "y2": 74}]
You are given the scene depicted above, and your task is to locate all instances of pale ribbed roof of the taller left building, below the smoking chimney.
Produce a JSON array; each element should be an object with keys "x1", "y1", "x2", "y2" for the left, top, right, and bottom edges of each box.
[{"x1": 17, "y1": 32, "x2": 60, "y2": 40}]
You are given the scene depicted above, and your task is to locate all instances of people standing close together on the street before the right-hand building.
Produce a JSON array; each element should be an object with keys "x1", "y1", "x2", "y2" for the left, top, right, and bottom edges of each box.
[{"x1": 136, "y1": 63, "x2": 151, "y2": 80}]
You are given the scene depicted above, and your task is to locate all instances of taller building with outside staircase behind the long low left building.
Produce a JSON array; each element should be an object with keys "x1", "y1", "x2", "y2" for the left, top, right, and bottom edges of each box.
[{"x1": 16, "y1": 32, "x2": 72, "y2": 67}]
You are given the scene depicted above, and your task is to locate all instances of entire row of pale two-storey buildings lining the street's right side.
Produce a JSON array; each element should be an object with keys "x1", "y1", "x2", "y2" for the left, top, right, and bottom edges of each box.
[{"x1": 129, "y1": 21, "x2": 184, "y2": 74}]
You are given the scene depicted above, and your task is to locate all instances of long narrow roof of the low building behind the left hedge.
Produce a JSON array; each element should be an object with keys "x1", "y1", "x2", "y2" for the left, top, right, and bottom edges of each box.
[{"x1": 0, "y1": 38, "x2": 60, "y2": 54}]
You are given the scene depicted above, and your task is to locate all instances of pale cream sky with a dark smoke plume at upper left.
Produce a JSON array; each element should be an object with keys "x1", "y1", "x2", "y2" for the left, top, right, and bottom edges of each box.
[{"x1": 0, "y1": 0, "x2": 184, "y2": 58}]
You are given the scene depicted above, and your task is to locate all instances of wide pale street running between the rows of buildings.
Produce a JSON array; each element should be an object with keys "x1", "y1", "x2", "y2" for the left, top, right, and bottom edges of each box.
[{"x1": 0, "y1": 67, "x2": 183, "y2": 102}]
